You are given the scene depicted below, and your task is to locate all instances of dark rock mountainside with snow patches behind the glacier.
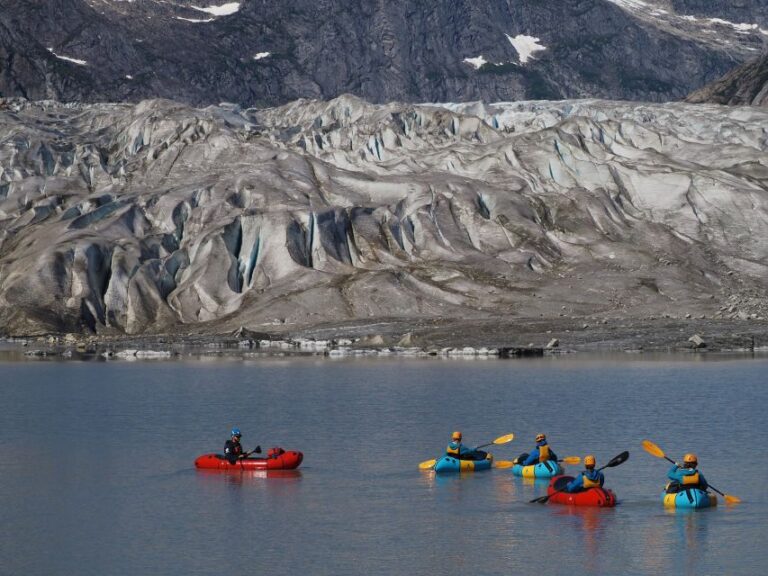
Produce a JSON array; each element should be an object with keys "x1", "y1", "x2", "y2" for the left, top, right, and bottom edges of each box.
[{"x1": 0, "y1": 0, "x2": 768, "y2": 106}]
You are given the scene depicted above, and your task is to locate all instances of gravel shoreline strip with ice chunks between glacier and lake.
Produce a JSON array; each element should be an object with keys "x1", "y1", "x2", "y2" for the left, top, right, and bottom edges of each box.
[{"x1": 3, "y1": 317, "x2": 768, "y2": 359}]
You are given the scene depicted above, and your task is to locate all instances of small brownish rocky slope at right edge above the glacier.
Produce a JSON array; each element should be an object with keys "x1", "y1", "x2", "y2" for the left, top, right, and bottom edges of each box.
[{"x1": 687, "y1": 54, "x2": 768, "y2": 107}]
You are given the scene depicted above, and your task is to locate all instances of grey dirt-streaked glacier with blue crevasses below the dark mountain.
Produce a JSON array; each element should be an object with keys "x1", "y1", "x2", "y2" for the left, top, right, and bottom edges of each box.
[{"x1": 0, "y1": 96, "x2": 768, "y2": 335}]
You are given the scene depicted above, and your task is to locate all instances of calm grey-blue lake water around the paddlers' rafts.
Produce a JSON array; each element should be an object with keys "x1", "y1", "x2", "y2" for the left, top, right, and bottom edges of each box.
[{"x1": 0, "y1": 356, "x2": 768, "y2": 576}]
